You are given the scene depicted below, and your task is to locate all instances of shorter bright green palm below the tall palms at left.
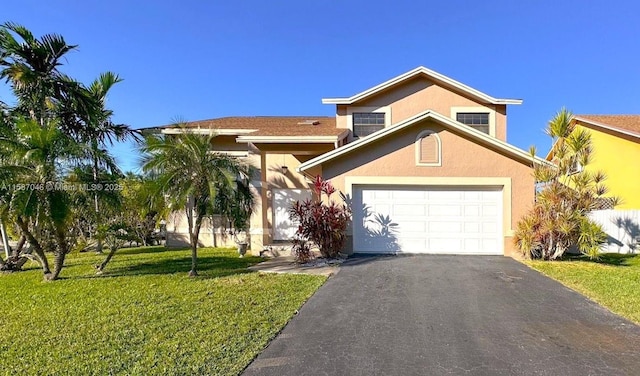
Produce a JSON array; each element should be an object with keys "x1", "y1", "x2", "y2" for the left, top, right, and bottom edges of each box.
[{"x1": 0, "y1": 118, "x2": 85, "y2": 280}]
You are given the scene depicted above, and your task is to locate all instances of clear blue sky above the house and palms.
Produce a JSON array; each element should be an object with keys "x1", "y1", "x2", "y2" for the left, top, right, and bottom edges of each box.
[{"x1": 0, "y1": 0, "x2": 640, "y2": 170}]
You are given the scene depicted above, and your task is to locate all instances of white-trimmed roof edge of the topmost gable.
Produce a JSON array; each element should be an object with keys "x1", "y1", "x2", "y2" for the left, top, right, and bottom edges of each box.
[{"x1": 322, "y1": 67, "x2": 522, "y2": 104}]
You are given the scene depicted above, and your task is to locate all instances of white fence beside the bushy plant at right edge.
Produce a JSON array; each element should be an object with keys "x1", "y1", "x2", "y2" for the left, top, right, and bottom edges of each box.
[{"x1": 589, "y1": 210, "x2": 640, "y2": 253}]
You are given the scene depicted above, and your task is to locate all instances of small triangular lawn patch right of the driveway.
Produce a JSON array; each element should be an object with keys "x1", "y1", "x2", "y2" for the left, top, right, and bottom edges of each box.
[{"x1": 526, "y1": 254, "x2": 640, "y2": 324}]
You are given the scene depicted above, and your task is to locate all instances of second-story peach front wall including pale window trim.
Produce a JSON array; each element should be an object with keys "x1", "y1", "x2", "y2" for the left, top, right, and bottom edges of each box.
[{"x1": 336, "y1": 77, "x2": 507, "y2": 141}]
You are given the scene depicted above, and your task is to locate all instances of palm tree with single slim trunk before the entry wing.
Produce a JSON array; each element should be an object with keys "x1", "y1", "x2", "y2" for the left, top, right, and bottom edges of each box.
[{"x1": 140, "y1": 129, "x2": 251, "y2": 276}]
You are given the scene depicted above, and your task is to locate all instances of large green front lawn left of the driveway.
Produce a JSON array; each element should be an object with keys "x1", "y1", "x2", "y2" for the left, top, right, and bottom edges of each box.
[{"x1": 0, "y1": 247, "x2": 325, "y2": 375}]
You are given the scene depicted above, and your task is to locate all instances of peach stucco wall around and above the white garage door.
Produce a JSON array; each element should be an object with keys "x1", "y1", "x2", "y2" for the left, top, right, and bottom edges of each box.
[{"x1": 323, "y1": 120, "x2": 534, "y2": 254}]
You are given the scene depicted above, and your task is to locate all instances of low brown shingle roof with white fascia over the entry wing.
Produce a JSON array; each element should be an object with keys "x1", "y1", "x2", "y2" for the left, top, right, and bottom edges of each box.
[{"x1": 160, "y1": 116, "x2": 345, "y2": 139}]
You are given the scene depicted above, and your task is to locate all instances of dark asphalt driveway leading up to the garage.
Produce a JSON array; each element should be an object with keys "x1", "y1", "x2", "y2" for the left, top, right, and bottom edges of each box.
[{"x1": 245, "y1": 255, "x2": 640, "y2": 376}]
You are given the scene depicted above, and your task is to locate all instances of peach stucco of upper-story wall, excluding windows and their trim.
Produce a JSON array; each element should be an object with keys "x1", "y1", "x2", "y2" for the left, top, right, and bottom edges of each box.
[{"x1": 336, "y1": 77, "x2": 507, "y2": 141}]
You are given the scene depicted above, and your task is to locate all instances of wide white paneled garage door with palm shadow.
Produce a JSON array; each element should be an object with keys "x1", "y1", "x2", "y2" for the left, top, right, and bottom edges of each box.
[{"x1": 353, "y1": 186, "x2": 503, "y2": 255}]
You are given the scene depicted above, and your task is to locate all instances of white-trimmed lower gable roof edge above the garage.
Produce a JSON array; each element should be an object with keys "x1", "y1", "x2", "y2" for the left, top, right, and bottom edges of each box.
[{"x1": 297, "y1": 110, "x2": 551, "y2": 171}]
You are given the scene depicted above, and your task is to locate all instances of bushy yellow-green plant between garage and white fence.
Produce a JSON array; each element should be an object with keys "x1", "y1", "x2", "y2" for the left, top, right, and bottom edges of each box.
[{"x1": 514, "y1": 108, "x2": 618, "y2": 260}]
